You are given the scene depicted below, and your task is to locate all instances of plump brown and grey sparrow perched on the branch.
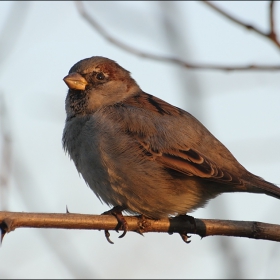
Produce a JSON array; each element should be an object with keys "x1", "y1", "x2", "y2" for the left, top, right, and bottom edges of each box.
[{"x1": 62, "y1": 56, "x2": 280, "y2": 242}]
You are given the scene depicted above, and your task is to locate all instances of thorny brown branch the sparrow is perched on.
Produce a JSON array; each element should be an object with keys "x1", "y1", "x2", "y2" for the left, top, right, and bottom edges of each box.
[{"x1": 0, "y1": 211, "x2": 280, "y2": 241}]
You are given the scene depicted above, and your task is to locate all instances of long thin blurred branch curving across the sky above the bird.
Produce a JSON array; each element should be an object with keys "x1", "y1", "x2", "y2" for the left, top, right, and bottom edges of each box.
[{"x1": 75, "y1": 1, "x2": 280, "y2": 71}]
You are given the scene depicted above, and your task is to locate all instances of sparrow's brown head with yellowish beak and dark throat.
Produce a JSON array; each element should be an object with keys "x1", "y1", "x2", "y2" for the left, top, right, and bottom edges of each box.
[{"x1": 63, "y1": 56, "x2": 140, "y2": 116}]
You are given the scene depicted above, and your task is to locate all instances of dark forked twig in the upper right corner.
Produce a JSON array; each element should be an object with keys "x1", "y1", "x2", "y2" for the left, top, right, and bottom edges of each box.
[{"x1": 203, "y1": 1, "x2": 280, "y2": 48}]
